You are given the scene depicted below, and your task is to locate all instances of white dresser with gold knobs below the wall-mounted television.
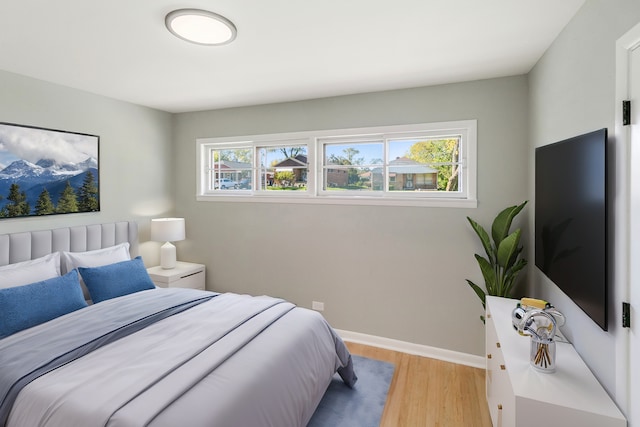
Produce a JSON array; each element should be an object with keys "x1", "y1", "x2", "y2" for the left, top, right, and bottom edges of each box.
[{"x1": 486, "y1": 296, "x2": 627, "y2": 427}]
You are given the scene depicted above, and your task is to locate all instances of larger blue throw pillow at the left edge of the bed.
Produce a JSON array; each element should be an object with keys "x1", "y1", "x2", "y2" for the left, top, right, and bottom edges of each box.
[{"x1": 0, "y1": 270, "x2": 87, "y2": 338}]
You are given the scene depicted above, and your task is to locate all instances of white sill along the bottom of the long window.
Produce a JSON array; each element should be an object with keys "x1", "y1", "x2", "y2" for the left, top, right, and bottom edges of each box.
[{"x1": 196, "y1": 194, "x2": 478, "y2": 209}]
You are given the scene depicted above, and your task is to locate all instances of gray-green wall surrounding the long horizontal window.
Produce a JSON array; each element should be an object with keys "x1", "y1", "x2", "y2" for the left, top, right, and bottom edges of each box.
[{"x1": 174, "y1": 76, "x2": 529, "y2": 355}]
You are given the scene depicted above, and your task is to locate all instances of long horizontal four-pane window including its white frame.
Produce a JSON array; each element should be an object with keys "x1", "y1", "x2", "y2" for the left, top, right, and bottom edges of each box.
[{"x1": 197, "y1": 120, "x2": 477, "y2": 207}]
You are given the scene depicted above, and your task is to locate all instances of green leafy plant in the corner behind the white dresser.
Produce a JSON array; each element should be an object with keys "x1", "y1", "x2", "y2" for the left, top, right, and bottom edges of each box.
[{"x1": 467, "y1": 201, "x2": 527, "y2": 322}]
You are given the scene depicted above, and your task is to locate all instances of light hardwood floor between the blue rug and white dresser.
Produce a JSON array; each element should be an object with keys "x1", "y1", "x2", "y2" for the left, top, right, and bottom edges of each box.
[{"x1": 347, "y1": 342, "x2": 491, "y2": 427}]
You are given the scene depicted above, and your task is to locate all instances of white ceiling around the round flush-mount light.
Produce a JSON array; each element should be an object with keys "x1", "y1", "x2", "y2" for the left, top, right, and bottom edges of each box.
[{"x1": 0, "y1": 0, "x2": 585, "y2": 112}]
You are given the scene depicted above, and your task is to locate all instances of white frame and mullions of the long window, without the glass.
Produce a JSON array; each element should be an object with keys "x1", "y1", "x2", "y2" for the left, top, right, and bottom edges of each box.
[{"x1": 196, "y1": 120, "x2": 478, "y2": 208}]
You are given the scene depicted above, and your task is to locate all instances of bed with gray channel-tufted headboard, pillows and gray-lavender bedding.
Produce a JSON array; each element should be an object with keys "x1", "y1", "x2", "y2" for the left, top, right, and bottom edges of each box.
[{"x1": 0, "y1": 222, "x2": 357, "y2": 427}]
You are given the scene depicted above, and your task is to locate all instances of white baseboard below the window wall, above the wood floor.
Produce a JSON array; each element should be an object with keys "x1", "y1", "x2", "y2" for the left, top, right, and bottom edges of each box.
[{"x1": 335, "y1": 329, "x2": 486, "y2": 369}]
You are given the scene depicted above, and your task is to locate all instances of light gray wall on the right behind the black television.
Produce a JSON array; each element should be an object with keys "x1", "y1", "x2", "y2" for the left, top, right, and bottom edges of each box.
[{"x1": 529, "y1": 0, "x2": 640, "y2": 406}]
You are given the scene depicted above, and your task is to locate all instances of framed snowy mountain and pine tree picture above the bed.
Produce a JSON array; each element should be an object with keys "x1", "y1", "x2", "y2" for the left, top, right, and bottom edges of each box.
[{"x1": 0, "y1": 123, "x2": 100, "y2": 219}]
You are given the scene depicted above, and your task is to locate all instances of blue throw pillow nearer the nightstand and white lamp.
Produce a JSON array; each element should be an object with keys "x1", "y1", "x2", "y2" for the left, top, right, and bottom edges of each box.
[{"x1": 78, "y1": 257, "x2": 156, "y2": 303}]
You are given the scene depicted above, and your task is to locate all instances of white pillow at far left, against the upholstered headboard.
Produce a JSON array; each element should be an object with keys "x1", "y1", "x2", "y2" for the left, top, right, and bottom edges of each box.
[{"x1": 0, "y1": 252, "x2": 60, "y2": 288}]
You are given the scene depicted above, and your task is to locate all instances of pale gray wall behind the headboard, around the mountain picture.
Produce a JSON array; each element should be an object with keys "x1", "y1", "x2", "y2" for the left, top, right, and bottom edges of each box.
[{"x1": 0, "y1": 71, "x2": 173, "y2": 265}]
